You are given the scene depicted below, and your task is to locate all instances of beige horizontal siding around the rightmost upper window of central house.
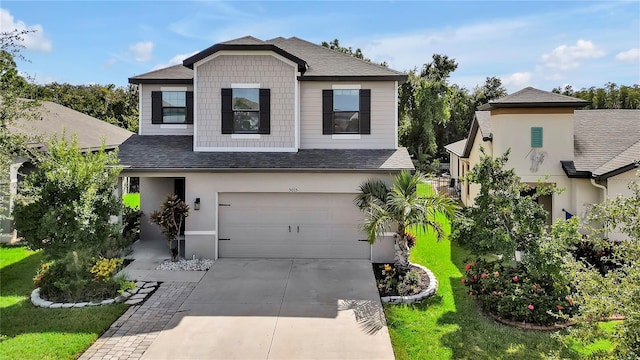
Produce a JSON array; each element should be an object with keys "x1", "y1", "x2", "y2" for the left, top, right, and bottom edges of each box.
[{"x1": 300, "y1": 81, "x2": 397, "y2": 149}]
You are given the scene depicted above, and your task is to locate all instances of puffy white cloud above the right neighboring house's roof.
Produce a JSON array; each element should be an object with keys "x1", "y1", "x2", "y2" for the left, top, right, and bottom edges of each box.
[{"x1": 540, "y1": 40, "x2": 606, "y2": 70}]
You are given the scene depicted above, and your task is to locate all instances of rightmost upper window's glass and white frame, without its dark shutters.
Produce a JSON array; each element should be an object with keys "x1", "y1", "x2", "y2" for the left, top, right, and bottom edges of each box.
[{"x1": 333, "y1": 90, "x2": 360, "y2": 134}]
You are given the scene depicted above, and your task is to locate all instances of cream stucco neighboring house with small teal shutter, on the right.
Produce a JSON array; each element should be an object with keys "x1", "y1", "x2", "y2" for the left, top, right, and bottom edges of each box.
[{"x1": 446, "y1": 87, "x2": 640, "y2": 238}]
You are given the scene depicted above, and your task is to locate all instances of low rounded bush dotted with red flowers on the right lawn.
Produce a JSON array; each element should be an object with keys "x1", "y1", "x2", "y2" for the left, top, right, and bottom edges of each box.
[{"x1": 462, "y1": 259, "x2": 577, "y2": 325}]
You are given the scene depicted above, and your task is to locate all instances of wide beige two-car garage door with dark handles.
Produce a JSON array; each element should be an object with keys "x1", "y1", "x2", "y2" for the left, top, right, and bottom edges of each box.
[{"x1": 218, "y1": 193, "x2": 370, "y2": 259}]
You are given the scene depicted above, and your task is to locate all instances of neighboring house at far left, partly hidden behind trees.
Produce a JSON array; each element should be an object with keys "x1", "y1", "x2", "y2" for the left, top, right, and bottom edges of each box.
[{"x1": 0, "y1": 101, "x2": 133, "y2": 242}]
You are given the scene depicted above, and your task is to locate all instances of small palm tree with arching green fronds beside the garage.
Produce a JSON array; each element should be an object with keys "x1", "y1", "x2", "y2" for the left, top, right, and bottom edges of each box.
[{"x1": 354, "y1": 171, "x2": 458, "y2": 272}]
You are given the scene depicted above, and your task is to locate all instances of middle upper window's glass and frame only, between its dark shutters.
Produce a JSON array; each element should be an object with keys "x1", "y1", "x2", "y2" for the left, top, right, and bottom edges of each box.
[{"x1": 232, "y1": 89, "x2": 260, "y2": 134}]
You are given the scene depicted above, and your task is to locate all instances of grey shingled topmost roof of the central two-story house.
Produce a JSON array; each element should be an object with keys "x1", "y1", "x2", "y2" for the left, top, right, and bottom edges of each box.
[{"x1": 129, "y1": 36, "x2": 407, "y2": 84}]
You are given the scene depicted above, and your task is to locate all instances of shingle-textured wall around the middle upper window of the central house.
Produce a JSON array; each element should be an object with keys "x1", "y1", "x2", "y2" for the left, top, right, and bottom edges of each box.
[{"x1": 194, "y1": 52, "x2": 297, "y2": 151}]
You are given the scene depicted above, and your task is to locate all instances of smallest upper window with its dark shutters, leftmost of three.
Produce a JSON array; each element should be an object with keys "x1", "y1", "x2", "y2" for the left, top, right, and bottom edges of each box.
[{"x1": 151, "y1": 91, "x2": 193, "y2": 124}]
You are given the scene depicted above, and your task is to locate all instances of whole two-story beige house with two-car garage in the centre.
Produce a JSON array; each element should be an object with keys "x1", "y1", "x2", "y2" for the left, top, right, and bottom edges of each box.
[{"x1": 119, "y1": 37, "x2": 413, "y2": 261}]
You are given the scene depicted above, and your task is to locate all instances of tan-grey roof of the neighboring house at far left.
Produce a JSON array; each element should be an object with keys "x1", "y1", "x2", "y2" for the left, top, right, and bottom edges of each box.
[{"x1": 11, "y1": 101, "x2": 133, "y2": 150}]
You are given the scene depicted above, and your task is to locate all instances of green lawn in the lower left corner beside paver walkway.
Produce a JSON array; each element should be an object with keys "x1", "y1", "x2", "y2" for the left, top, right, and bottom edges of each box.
[{"x1": 0, "y1": 247, "x2": 127, "y2": 360}]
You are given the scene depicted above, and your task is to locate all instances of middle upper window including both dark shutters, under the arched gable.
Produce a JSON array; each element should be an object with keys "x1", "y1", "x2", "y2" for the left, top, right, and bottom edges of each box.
[{"x1": 221, "y1": 87, "x2": 271, "y2": 134}]
